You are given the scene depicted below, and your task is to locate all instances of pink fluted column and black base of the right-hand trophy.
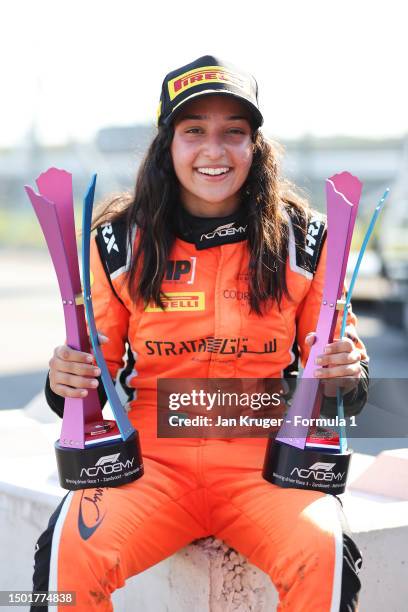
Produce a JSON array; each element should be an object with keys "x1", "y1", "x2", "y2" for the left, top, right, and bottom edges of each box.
[{"x1": 263, "y1": 172, "x2": 362, "y2": 495}]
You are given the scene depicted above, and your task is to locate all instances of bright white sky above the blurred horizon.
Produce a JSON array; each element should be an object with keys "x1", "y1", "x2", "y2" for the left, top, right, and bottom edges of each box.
[{"x1": 0, "y1": 0, "x2": 408, "y2": 147}]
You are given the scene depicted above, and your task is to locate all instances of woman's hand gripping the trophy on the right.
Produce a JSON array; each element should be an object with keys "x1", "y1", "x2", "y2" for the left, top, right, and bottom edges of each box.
[{"x1": 306, "y1": 333, "x2": 362, "y2": 397}]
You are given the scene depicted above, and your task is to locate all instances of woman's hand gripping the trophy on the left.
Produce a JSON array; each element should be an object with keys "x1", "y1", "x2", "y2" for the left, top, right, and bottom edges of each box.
[{"x1": 48, "y1": 333, "x2": 109, "y2": 397}]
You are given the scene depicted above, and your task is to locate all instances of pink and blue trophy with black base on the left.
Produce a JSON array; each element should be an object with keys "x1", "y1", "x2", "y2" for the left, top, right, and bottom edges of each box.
[{"x1": 25, "y1": 168, "x2": 143, "y2": 490}]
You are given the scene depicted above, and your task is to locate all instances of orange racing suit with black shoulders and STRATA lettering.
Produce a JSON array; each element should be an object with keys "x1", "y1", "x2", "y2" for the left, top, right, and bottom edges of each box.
[{"x1": 34, "y1": 207, "x2": 367, "y2": 612}]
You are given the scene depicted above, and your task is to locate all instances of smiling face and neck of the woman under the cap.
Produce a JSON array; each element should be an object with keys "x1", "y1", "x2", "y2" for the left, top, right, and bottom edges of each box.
[{"x1": 171, "y1": 95, "x2": 253, "y2": 217}]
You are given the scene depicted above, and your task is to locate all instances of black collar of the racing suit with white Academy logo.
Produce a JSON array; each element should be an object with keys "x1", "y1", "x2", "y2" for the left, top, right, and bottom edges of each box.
[{"x1": 174, "y1": 204, "x2": 248, "y2": 250}]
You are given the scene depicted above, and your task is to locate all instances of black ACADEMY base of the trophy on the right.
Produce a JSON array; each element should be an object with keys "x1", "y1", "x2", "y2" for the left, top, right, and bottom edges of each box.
[{"x1": 262, "y1": 439, "x2": 352, "y2": 495}]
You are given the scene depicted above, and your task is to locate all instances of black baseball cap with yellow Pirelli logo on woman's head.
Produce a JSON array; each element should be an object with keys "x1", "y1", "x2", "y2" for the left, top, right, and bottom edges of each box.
[{"x1": 157, "y1": 55, "x2": 263, "y2": 128}]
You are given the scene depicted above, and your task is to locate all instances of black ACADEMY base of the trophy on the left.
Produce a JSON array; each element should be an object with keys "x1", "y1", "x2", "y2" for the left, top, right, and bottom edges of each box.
[{"x1": 54, "y1": 431, "x2": 144, "y2": 491}]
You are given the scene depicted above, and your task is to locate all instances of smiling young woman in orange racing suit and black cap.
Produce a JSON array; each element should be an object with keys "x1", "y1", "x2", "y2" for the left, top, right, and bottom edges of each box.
[{"x1": 34, "y1": 56, "x2": 367, "y2": 612}]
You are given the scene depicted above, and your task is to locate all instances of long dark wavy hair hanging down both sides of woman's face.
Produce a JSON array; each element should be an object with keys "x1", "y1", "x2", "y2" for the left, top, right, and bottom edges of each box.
[{"x1": 92, "y1": 125, "x2": 309, "y2": 314}]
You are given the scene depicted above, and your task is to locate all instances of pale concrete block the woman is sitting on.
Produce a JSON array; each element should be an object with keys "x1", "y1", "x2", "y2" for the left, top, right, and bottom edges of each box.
[{"x1": 0, "y1": 394, "x2": 408, "y2": 612}]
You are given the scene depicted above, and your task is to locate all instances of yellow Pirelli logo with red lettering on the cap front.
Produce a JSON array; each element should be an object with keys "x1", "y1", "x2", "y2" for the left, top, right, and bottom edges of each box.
[{"x1": 167, "y1": 66, "x2": 250, "y2": 100}]
